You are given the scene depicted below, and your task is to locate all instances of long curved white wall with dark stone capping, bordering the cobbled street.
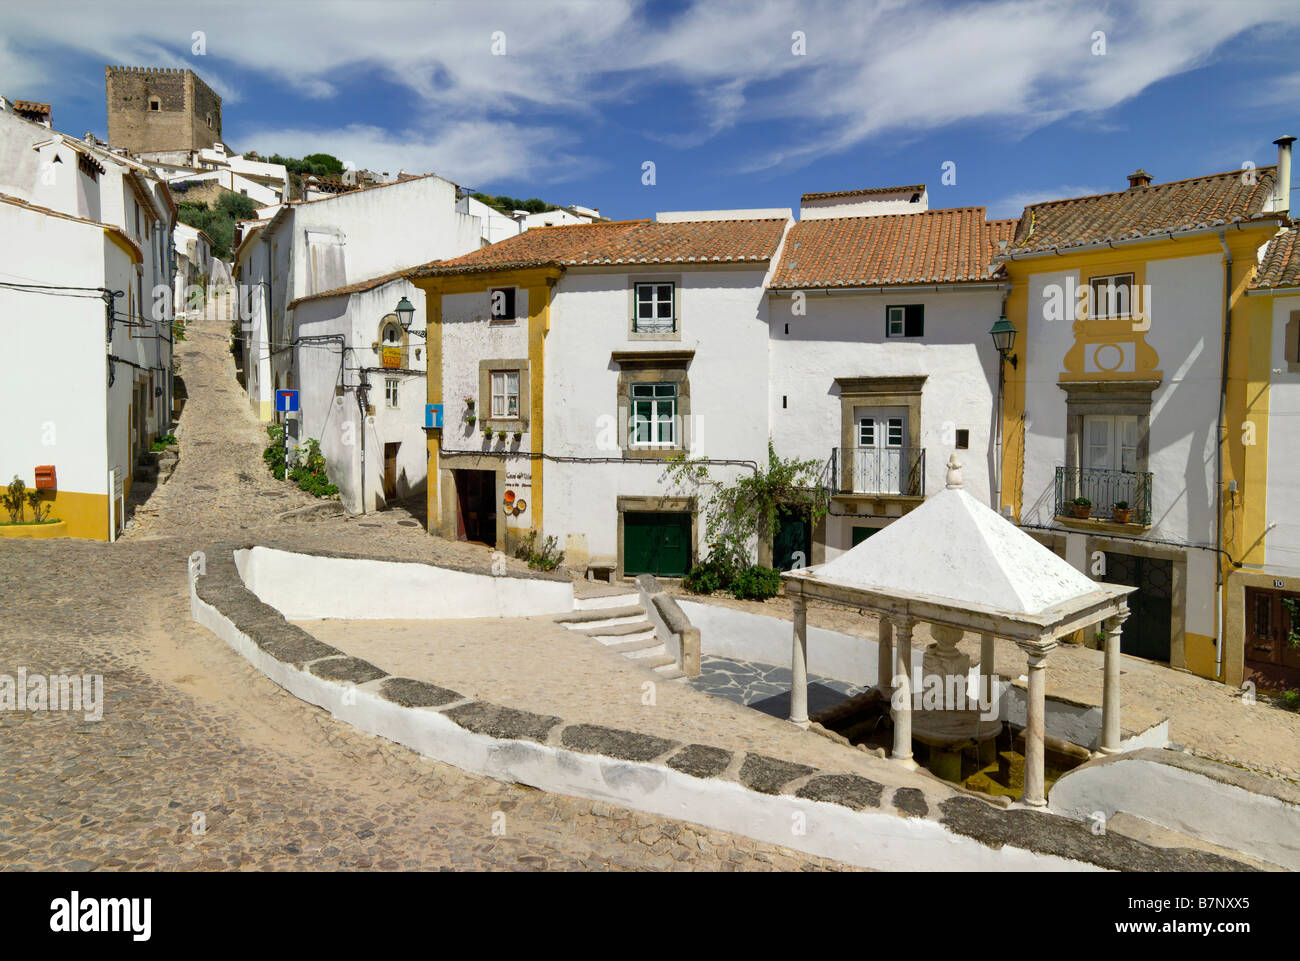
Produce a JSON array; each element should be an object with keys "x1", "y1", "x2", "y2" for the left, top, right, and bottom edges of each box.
[{"x1": 190, "y1": 545, "x2": 1248, "y2": 871}]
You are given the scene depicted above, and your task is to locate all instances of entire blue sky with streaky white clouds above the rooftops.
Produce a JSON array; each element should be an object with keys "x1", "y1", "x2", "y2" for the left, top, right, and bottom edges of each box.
[{"x1": 10, "y1": 0, "x2": 1300, "y2": 218}]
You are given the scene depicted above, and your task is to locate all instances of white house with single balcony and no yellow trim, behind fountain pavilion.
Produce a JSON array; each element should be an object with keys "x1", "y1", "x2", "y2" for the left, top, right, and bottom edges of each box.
[{"x1": 768, "y1": 200, "x2": 1015, "y2": 570}]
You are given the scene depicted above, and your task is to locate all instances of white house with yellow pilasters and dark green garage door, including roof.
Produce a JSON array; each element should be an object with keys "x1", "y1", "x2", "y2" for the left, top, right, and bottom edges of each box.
[{"x1": 411, "y1": 209, "x2": 790, "y2": 575}]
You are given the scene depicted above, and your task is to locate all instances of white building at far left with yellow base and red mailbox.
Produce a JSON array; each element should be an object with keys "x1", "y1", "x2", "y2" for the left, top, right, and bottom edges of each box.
[{"x1": 0, "y1": 111, "x2": 176, "y2": 540}]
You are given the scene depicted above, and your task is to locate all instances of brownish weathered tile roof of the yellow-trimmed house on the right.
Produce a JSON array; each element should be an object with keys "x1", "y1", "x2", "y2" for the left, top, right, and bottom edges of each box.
[{"x1": 1008, "y1": 166, "x2": 1277, "y2": 254}]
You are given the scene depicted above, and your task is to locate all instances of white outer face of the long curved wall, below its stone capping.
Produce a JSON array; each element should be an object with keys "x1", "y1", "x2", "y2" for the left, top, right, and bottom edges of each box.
[{"x1": 190, "y1": 566, "x2": 1100, "y2": 871}]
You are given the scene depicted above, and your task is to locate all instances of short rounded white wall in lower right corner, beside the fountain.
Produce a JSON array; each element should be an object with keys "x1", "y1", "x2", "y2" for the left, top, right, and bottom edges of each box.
[{"x1": 1050, "y1": 757, "x2": 1300, "y2": 871}]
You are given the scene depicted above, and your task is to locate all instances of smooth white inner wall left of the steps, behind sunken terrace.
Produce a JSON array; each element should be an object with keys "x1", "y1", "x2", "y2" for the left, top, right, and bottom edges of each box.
[{"x1": 235, "y1": 547, "x2": 573, "y2": 620}]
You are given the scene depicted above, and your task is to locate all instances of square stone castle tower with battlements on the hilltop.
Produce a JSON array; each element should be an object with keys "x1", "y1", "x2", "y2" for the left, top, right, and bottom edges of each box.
[{"x1": 104, "y1": 66, "x2": 221, "y2": 153}]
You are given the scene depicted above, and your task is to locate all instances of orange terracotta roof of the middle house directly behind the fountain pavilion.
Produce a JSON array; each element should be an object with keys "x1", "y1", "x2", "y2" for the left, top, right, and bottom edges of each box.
[{"x1": 768, "y1": 207, "x2": 1015, "y2": 290}]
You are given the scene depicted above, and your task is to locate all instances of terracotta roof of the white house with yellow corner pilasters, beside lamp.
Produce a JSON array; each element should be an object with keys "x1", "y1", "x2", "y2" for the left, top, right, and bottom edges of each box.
[{"x1": 408, "y1": 218, "x2": 787, "y2": 277}]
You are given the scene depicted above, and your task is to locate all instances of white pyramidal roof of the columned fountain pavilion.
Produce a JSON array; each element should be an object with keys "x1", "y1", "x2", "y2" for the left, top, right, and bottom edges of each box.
[{"x1": 806, "y1": 481, "x2": 1105, "y2": 615}]
